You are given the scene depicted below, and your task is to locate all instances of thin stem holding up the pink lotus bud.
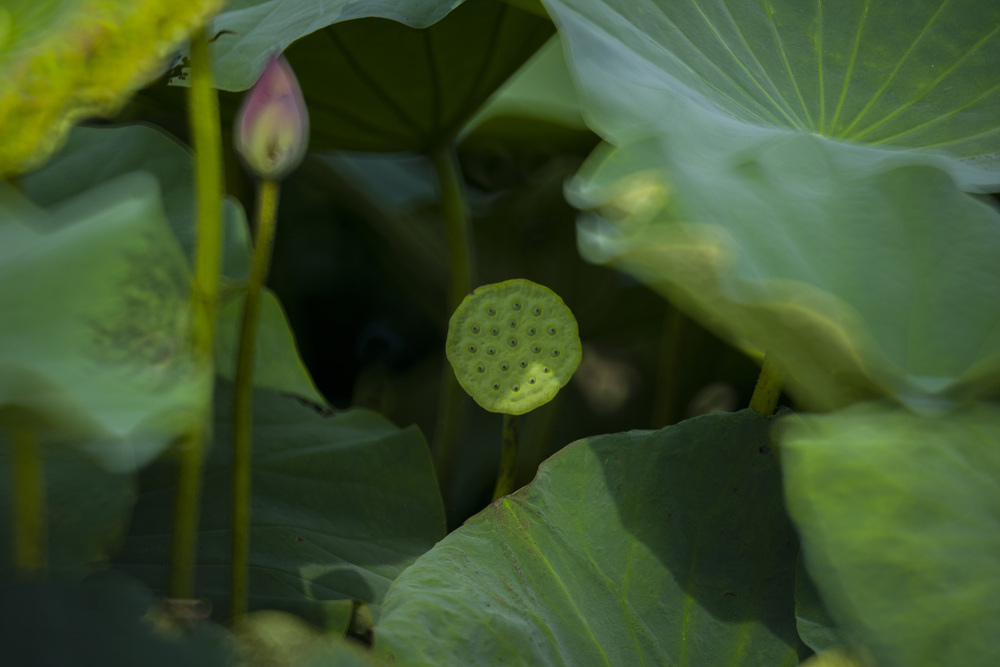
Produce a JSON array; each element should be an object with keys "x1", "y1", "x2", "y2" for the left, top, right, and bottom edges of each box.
[{"x1": 229, "y1": 181, "x2": 279, "y2": 621}]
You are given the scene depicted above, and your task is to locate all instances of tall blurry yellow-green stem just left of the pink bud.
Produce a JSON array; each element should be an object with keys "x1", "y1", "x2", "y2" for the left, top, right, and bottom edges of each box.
[{"x1": 167, "y1": 31, "x2": 223, "y2": 598}]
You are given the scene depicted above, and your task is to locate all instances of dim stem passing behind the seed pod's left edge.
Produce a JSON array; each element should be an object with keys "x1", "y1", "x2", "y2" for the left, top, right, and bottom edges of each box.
[{"x1": 431, "y1": 145, "x2": 475, "y2": 494}]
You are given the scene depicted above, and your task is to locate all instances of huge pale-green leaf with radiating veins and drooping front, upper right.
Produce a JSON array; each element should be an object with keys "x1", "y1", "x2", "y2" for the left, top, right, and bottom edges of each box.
[{"x1": 547, "y1": 0, "x2": 1000, "y2": 409}]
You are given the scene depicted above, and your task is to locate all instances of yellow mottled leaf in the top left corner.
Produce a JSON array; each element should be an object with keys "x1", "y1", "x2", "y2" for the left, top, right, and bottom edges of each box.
[{"x1": 0, "y1": 0, "x2": 224, "y2": 177}]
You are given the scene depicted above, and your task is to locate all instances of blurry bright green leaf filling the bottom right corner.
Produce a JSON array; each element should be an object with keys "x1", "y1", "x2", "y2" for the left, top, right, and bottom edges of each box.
[{"x1": 781, "y1": 404, "x2": 1000, "y2": 667}]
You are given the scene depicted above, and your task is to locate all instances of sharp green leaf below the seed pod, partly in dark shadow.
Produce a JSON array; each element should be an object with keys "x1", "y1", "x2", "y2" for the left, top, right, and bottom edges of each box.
[{"x1": 375, "y1": 411, "x2": 800, "y2": 667}]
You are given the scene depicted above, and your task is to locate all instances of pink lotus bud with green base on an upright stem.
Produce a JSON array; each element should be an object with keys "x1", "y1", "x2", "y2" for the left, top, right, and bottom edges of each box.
[{"x1": 235, "y1": 55, "x2": 309, "y2": 181}]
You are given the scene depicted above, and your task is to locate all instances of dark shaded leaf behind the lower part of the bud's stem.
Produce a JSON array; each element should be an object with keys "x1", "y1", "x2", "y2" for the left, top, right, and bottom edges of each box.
[{"x1": 115, "y1": 384, "x2": 444, "y2": 629}]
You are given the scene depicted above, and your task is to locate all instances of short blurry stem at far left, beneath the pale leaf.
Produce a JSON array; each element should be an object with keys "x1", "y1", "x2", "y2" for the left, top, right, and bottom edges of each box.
[{"x1": 10, "y1": 426, "x2": 48, "y2": 579}]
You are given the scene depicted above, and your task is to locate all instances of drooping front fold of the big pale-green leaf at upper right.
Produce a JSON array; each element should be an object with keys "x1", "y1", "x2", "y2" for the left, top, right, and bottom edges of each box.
[{"x1": 577, "y1": 136, "x2": 1000, "y2": 409}]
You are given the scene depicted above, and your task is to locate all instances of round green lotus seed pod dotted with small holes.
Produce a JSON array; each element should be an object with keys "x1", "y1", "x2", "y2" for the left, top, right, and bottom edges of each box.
[{"x1": 446, "y1": 279, "x2": 582, "y2": 415}]
